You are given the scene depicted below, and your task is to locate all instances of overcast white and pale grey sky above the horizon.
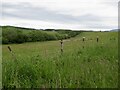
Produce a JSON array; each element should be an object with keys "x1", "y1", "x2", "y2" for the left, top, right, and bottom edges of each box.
[{"x1": 0, "y1": 0, "x2": 119, "y2": 31}]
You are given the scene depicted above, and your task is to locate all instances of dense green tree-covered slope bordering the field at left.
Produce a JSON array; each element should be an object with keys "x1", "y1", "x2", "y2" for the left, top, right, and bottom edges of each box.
[{"x1": 1, "y1": 26, "x2": 80, "y2": 44}]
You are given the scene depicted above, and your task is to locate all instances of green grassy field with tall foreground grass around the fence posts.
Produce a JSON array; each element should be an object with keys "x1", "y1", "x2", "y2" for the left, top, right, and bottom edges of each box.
[{"x1": 2, "y1": 32, "x2": 118, "y2": 88}]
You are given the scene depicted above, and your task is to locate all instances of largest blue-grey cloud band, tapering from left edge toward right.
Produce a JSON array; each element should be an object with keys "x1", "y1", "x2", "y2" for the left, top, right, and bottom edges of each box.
[{"x1": 3, "y1": 3, "x2": 101, "y2": 24}]
